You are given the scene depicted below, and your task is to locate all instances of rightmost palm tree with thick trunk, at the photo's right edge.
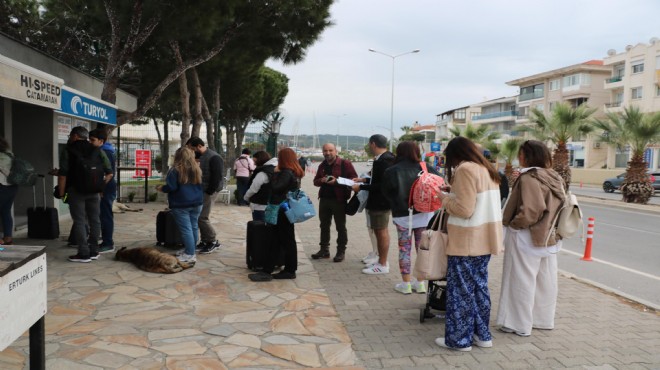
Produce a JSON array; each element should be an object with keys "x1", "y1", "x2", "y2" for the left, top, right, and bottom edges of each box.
[{"x1": 594, "y1": 106, "x2": 660, "y2": 204}]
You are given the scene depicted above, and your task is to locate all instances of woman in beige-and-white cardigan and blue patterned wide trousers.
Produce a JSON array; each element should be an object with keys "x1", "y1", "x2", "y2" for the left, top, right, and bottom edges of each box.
[{"x1": 435, "y1": 136, "x2": 502, "y2": 351}]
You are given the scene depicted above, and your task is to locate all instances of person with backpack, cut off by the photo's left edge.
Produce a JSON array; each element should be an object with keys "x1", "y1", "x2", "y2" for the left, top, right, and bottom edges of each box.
[{"x1": 0, "y1": 137, "x2": 18, "y2": 245}]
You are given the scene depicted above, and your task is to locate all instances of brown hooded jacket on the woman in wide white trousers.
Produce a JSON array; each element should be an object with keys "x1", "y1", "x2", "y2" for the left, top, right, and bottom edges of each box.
[{"x1": 502, "y1": 168, "x2": 564, "y2": 247}]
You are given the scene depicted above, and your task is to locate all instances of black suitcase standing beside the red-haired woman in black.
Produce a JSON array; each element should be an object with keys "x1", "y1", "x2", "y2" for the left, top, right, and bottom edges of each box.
[{"x1": 245, "y1": 221, "x2": 284, "y2": 271}]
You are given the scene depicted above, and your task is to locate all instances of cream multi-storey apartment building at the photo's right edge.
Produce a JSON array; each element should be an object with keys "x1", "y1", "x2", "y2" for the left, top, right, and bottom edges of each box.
[{"x1": 603, "y1": 37, "x2": 660, "y2": 169}]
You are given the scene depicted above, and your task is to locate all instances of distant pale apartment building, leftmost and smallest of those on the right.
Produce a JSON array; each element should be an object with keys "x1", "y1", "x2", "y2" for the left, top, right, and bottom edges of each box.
[{"x1": 470, "y1": 96, "x2": 519, "y2": 139}]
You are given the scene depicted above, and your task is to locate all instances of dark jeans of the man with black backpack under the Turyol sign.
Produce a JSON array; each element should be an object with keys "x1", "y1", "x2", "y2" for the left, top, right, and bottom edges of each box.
[{"x1": 68, "y1": 188, "x2": 101, "y2": 257}]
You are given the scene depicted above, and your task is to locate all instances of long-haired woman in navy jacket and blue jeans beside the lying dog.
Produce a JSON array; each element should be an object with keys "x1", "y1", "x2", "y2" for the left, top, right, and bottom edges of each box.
[{"x1": 156, "y1": 146, "x2": 204, "y2": 263}]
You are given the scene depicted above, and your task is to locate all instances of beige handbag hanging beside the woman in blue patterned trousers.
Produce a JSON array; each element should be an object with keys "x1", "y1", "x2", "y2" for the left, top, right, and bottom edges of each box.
[{"x1": 413, "y1": 208, "x2": 448, "y2": 281}]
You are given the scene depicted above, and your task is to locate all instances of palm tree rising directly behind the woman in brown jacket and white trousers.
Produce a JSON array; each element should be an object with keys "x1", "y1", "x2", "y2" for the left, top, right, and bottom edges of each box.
[{"x1": 520, "y1": 103, "x2": 596, "y2": 189}]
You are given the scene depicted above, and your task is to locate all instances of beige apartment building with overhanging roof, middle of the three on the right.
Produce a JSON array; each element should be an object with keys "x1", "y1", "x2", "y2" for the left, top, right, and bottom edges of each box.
[{"x1": 506, "y1": 60, "x2": 612, "y2": 168}]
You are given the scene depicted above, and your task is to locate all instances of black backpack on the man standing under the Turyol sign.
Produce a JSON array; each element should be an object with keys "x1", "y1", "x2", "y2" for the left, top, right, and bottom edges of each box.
[{"x1": 69, "y1": 148, "x2": 105, "y2": 194}]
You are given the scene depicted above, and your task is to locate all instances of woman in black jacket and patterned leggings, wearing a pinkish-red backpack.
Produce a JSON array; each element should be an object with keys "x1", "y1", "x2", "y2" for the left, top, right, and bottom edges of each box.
[{"x1": 383, "y1": 141, "x2": 438, "y2": 294}]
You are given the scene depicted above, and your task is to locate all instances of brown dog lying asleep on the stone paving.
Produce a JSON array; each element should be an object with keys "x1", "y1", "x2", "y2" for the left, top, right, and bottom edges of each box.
[{"x1": 115, "y1": 247, "x2": 195, "y2": 274}]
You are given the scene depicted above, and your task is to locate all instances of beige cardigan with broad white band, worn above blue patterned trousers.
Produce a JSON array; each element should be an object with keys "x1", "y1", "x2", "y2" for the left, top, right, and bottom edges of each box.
[{"x1": 442, "y1": 162, "x2": 503, "y2": 256}]
